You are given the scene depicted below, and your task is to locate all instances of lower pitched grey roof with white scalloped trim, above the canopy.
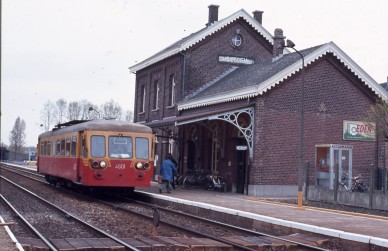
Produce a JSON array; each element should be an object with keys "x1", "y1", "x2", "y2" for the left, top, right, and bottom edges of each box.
[{"x1": 178, "y1": 42, "x2": 388, "y2": 110}]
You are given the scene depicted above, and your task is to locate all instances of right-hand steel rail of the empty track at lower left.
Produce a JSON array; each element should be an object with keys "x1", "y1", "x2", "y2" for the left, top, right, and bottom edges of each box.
[{"x1": 0, "y1": 176, "x2": 140, "y2": 251}]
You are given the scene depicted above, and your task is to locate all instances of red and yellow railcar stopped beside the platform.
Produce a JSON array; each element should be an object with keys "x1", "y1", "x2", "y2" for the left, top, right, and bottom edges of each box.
[{"x1": 37, "y1": 120, "x2": 154, "y2": 191}]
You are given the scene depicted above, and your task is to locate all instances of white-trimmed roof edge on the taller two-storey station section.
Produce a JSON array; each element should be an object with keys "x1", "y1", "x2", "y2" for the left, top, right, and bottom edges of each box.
[{"x1": 129, "y1": 9, "x2": 273, "y2": 73}]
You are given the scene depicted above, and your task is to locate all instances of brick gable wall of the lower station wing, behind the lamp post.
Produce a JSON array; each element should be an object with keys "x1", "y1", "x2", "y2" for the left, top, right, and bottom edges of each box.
[{"x1": 250, "y1": 55, "x2": 376, "y2": 185}]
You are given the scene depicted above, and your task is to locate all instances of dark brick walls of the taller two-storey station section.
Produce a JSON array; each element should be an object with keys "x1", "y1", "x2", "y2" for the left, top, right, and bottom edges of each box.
[{"x1": 134, "y1": 19, "x2": 272, "y2": 122}]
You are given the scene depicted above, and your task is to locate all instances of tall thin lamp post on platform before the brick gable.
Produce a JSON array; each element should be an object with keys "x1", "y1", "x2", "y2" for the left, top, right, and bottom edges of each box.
[{"x1": 285, "y1": 39, "x2": 304, "y2": 209}]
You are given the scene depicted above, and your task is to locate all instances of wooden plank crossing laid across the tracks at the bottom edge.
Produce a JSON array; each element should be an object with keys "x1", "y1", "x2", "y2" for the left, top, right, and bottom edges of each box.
[{"x1": 18, "y1": 234, "x2": 330, "y2": 251}]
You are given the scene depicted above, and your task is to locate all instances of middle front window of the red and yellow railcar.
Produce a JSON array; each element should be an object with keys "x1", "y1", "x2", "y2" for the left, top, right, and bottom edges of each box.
[{"x1": 109, "y1": 136, "x2": 132, "y2": 159}]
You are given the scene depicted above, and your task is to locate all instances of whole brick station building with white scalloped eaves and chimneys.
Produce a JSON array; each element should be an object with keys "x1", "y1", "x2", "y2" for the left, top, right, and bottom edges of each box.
[{"x1": 129, "y1": 5, "x2": 387, "y2": 196}]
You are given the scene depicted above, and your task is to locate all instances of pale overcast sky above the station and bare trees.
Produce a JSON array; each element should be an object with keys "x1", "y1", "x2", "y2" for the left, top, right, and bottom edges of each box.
[{"x1": 1, "y1": 0, "x2": 388, "y2": 146}]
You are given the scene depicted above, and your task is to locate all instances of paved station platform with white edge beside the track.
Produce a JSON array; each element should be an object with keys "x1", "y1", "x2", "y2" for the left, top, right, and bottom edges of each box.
[{"x1": 136, "y1": 182, "x2": 388, "y2": 250}]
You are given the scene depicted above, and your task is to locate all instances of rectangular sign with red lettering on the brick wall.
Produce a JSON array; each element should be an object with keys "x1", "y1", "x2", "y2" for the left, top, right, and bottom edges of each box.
[{"x1": 343, "y1": 120, "x2": 376, "y2": 141}]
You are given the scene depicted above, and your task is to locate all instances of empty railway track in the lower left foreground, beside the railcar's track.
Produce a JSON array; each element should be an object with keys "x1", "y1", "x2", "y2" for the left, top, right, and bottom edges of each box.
[{"x1": 1, "y1": 176, "x2": 139, "y2": 250}]
